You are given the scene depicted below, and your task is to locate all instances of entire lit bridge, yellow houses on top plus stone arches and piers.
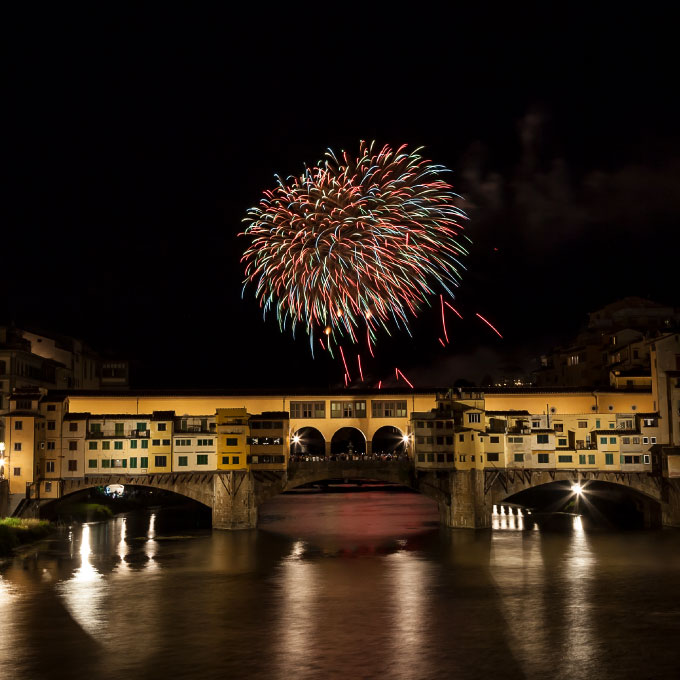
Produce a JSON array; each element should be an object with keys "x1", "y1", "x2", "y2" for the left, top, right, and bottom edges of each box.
[{"x1": 3, "y1": 380, "x2": 680, "y2": 528}]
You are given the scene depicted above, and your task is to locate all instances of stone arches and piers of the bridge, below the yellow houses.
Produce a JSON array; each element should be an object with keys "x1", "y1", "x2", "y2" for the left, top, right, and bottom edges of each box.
[{"x1": 41, "y1": 460, "x2": 680, "y2": 529}]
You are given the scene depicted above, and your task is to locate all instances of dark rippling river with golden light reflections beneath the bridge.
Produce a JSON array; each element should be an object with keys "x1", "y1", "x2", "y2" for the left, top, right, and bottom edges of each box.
[{"x1": 0, "y1": 490, "x2": 680, "y2": 680}]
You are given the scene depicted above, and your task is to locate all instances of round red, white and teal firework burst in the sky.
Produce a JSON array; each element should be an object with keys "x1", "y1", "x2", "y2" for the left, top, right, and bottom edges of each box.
[{"x1": 241, "y1": 142, "x2": 469, "y2": 351}]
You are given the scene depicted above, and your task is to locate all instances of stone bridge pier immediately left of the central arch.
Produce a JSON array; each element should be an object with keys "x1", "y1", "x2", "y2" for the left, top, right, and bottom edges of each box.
[{"x1": 212, "y1": 471, "x2": 257, "y2": 530}]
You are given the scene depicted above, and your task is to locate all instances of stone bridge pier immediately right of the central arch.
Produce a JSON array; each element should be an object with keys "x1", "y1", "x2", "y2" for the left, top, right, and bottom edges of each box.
[{"x1": 438, "y1": 470, "x2": 492, "y2": 529}]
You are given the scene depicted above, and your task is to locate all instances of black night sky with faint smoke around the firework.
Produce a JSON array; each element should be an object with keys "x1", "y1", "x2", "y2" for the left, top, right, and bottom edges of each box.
[{"x1": 0, "y1": 3, "x2": 680, "y2": 387}]
